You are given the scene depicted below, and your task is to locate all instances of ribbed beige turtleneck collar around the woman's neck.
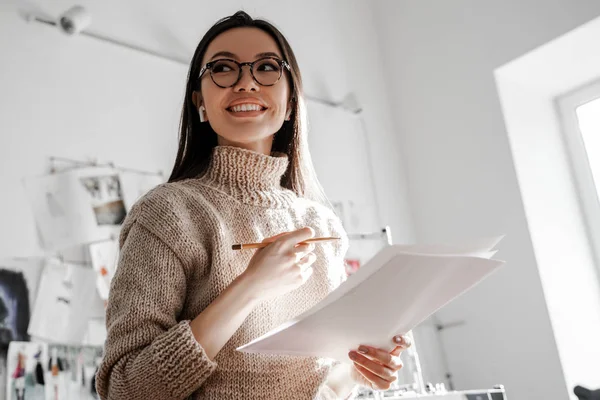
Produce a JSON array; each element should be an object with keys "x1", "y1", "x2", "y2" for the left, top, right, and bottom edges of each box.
[{"x1": 200, "y1": 146, "x2": 295, "y2": 208}]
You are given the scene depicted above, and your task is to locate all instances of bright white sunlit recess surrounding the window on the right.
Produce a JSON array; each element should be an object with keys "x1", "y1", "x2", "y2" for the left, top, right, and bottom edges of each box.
[{"x1": 495, "y1": 14, "x2": 600, "y2": 398}]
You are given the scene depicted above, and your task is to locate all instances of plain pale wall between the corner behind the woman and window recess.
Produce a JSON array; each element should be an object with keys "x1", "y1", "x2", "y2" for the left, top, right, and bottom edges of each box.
[{"x1": 376, "y1": 0, "x2": 600, "y2": 400}]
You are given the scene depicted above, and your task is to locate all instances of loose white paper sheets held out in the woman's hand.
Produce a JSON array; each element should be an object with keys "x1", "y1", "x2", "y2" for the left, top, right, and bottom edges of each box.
[{"x1": 238, "y1": 239, "x2": 504, "y2": 361}]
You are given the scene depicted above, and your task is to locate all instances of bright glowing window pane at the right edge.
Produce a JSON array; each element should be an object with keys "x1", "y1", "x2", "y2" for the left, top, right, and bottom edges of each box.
[{"x1": 557, "y1": 81, "x2": 600, "y2": 268}]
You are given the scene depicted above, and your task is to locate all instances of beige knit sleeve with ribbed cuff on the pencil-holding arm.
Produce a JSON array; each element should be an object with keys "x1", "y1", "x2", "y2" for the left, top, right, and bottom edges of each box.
[{"x1": 96, "y1": 205, "x2": 216, "y2": 400}]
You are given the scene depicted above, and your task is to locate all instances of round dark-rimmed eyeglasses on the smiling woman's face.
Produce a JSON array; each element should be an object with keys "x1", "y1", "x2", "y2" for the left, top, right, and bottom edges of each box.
[{"x1": 198, "y1": 57, "x2": 290, "y2": 88}]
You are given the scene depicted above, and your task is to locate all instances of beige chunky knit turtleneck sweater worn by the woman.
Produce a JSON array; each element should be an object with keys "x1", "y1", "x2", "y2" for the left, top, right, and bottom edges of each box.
[{"x1": 97, "y1": 146, "x2": 348, "y2": 400}]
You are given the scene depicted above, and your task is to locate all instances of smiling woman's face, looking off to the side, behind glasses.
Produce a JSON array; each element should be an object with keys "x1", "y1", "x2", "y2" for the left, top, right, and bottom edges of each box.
[{"x1": 194, "y1": 28, "x2": 291, "y2": 150}]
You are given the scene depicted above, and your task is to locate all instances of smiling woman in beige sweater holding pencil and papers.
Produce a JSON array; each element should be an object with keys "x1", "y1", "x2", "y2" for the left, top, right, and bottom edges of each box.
[{"x1": 97, "y1": 12, "x2": 409, "y2": 400}]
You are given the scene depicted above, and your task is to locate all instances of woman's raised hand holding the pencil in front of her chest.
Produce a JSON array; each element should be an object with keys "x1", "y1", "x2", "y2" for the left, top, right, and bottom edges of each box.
[{"x1": 240, "y1": 227, "x2": 316, "y2": 301}]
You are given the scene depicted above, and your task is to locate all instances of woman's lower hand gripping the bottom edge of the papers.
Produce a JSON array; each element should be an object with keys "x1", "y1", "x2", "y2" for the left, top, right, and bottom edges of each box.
[{"x1": 348, "y1": 335, "x2": 411, "y2": 390}]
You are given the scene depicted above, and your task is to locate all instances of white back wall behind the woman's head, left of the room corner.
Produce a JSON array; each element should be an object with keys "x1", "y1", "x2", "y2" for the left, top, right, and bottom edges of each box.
[{"x1": 0, "y1": 0, "x2": 413, "y2": 258}]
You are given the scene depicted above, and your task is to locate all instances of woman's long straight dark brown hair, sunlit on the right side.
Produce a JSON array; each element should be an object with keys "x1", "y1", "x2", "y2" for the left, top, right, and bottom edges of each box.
[{"x1": 169, "y1": 11, "x2": 328, "y2": 204}]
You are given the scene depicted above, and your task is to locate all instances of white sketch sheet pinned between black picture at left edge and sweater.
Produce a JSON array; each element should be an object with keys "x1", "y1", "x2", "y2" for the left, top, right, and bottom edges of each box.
[{"x1": 28, "y1": 259, "x2": 104, "y2": 344}]
